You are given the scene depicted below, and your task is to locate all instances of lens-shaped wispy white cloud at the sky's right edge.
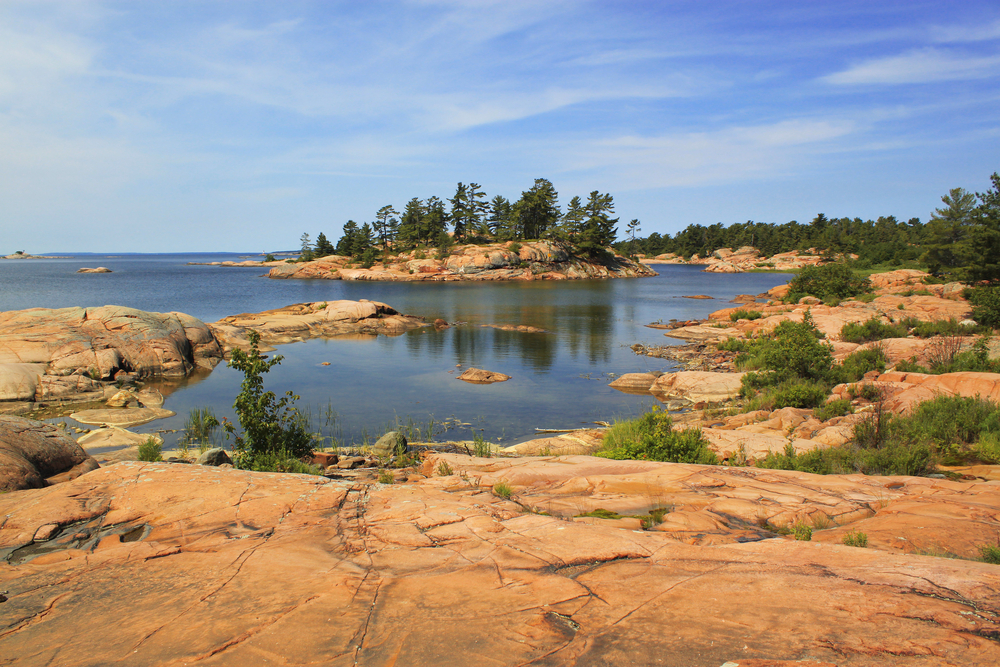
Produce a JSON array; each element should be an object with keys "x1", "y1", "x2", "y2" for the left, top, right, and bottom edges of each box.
[{"x1": 823, "y1": 48, "x2": 1000, "y2": 85}]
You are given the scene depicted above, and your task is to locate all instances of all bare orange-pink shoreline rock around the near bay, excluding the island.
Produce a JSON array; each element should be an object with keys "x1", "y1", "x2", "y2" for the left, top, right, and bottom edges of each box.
[{"x1": 0, "y1": 272, "x2": 1000, "y2": 667}]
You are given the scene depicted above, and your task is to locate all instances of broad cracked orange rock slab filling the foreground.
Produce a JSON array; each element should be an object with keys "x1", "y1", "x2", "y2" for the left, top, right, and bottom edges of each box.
[{"x1": 0, "y1": 454, "x2": 1000, "y2": 666}]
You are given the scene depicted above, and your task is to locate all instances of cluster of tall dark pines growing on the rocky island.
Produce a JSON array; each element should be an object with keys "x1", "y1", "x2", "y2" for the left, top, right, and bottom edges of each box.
[{"x1": 292, "y1": 178, "x2": 639, "y2": 266}]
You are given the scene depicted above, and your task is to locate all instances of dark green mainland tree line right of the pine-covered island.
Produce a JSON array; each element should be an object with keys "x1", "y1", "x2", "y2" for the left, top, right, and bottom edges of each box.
[{"x1": 615, "y1": 173, "x2": 1000, "y2": 282}]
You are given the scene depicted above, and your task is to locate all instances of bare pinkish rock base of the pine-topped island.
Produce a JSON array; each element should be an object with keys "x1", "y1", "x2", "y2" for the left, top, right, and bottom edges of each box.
[{"x1": 268, "y1": 241, "x2": 656, "y2": 282}]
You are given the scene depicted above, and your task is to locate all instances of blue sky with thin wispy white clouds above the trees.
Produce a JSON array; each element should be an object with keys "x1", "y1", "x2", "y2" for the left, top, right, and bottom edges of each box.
[{"x1": 0, "y1": 0, "x2": 1000, "y2": 253}]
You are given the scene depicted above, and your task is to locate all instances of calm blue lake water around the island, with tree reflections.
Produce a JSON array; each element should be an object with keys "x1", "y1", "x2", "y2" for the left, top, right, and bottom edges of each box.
[{"x1": 0, "y1": 254, "x2": 790, "y2": 444}]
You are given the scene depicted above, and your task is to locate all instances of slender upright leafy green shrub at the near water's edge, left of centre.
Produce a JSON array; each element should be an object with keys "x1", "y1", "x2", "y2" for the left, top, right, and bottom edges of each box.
[{"x1": 223, "y1": 329, "x2": 313, "y2": 469}]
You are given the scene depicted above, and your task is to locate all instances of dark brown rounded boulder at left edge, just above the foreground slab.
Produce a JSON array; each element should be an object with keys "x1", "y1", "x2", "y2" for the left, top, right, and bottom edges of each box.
[{"x1": 0, "y1": 415, "x2": 98, "y2": 494}]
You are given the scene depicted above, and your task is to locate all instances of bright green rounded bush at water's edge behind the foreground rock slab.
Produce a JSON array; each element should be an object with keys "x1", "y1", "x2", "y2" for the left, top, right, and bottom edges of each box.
[{"x1": 594, "y1": 407, "x2": 719, "y2": 465}]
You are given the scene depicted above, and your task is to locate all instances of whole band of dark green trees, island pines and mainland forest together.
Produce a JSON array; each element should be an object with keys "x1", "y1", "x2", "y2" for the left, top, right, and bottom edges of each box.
[{"x1": 301, "y1": 173, "x2": 1000, "y2": 282}]
